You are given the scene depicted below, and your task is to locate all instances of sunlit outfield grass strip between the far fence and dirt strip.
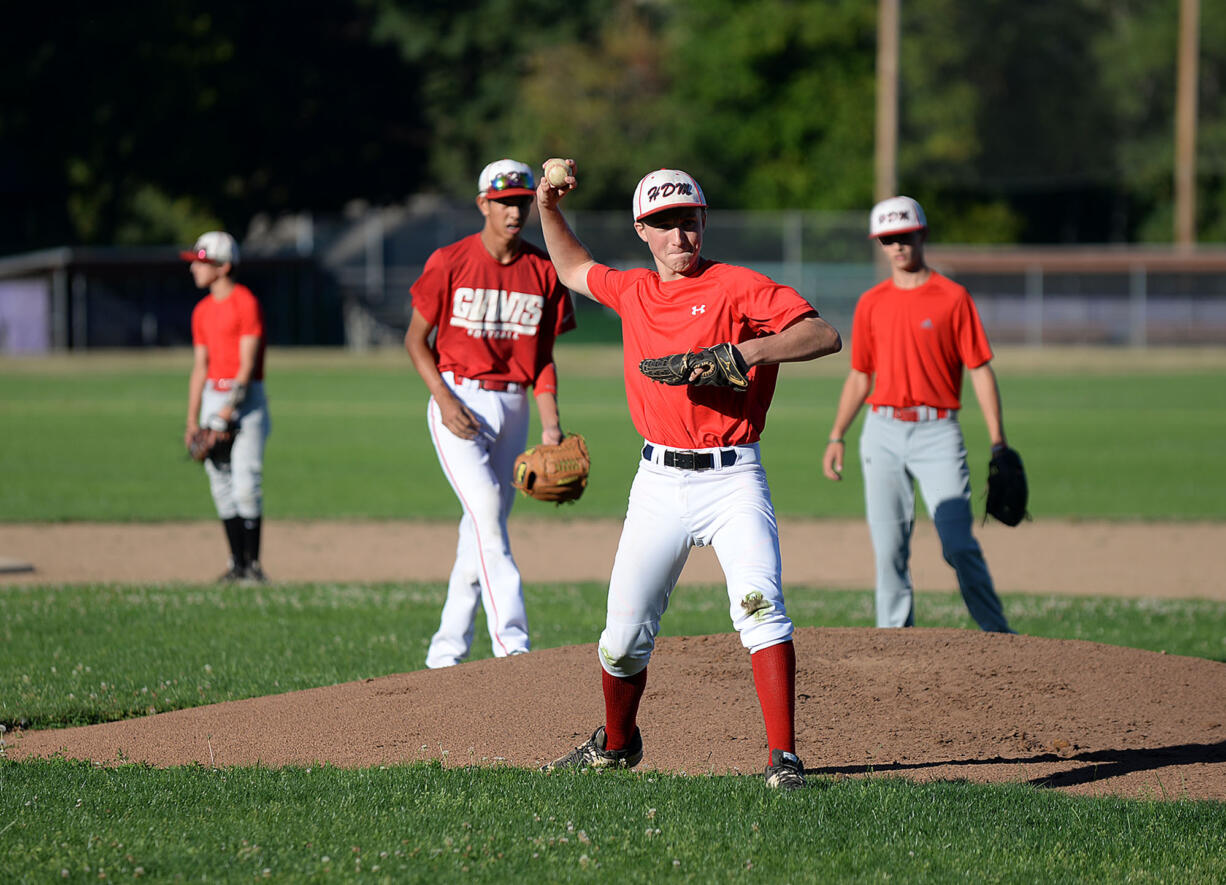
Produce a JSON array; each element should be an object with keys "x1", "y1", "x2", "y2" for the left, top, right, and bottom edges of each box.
[{"x1": 0, "y1": 344, "x2": 1226, "y2": 522}]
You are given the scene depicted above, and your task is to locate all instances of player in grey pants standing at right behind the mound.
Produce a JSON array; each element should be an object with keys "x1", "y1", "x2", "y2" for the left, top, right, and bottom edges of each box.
[{"x1": 821, "y1": 196, "x2": 1013, "y2": 632}]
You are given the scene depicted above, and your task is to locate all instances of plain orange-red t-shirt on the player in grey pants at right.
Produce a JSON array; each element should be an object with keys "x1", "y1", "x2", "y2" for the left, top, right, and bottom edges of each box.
[{"x1": 851, "y1": 271, "x2": 992, "y2": 408}]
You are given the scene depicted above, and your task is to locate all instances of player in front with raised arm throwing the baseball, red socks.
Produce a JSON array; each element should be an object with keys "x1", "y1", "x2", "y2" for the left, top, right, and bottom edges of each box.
[{"x1": 537, "y1": 164, "x2": 842, "y2": 788}]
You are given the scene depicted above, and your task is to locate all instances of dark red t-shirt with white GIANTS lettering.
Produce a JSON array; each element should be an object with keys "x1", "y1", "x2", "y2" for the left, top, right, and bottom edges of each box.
[{"x1": 409, "y1": 234, "x2": 575, "y2": 392}]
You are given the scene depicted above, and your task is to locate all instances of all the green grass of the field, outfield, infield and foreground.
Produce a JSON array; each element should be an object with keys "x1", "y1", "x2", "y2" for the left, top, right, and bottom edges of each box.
[{"x1": 0, "y1": 347, "x2": 1226, "y2": 883}]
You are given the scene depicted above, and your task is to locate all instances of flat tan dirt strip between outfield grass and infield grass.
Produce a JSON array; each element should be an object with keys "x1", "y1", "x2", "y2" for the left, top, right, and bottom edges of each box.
[{"x1": 0, "y1": 518, "x2": 1226, "y2": 599}]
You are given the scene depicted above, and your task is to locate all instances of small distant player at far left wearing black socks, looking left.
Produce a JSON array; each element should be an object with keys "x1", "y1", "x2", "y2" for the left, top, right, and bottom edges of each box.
[{"x1": 180, "y1": 230, "x2": 272, "y2": 583}]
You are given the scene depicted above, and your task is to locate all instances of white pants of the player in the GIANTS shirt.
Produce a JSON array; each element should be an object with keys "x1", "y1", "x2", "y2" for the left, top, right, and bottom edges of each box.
[{"x1": 425, "y1": 373, "x2": 531, "y2": 668}]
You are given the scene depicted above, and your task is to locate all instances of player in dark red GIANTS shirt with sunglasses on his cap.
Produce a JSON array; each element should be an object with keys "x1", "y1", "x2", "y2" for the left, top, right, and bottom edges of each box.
[{"x1": 405, "y1": 159, "x2": 575, "y2": 668}]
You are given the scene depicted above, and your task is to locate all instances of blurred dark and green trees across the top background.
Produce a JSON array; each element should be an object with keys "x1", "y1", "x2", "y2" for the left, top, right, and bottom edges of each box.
[{"x1": 0, "y1": 0, "x2": 1226, "y2": 251}]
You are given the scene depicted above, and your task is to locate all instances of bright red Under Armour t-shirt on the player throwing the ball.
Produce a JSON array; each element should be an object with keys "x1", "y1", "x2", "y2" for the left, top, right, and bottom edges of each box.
[{"x1": 587, "y1": 260, "x2": 817, "y2": 449}]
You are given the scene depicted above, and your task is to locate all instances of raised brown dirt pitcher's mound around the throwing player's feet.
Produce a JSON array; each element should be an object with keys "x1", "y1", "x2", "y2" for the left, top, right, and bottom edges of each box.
[{"x1": 6, "y1": 628, "x2": 1226, "y2": 800}]
